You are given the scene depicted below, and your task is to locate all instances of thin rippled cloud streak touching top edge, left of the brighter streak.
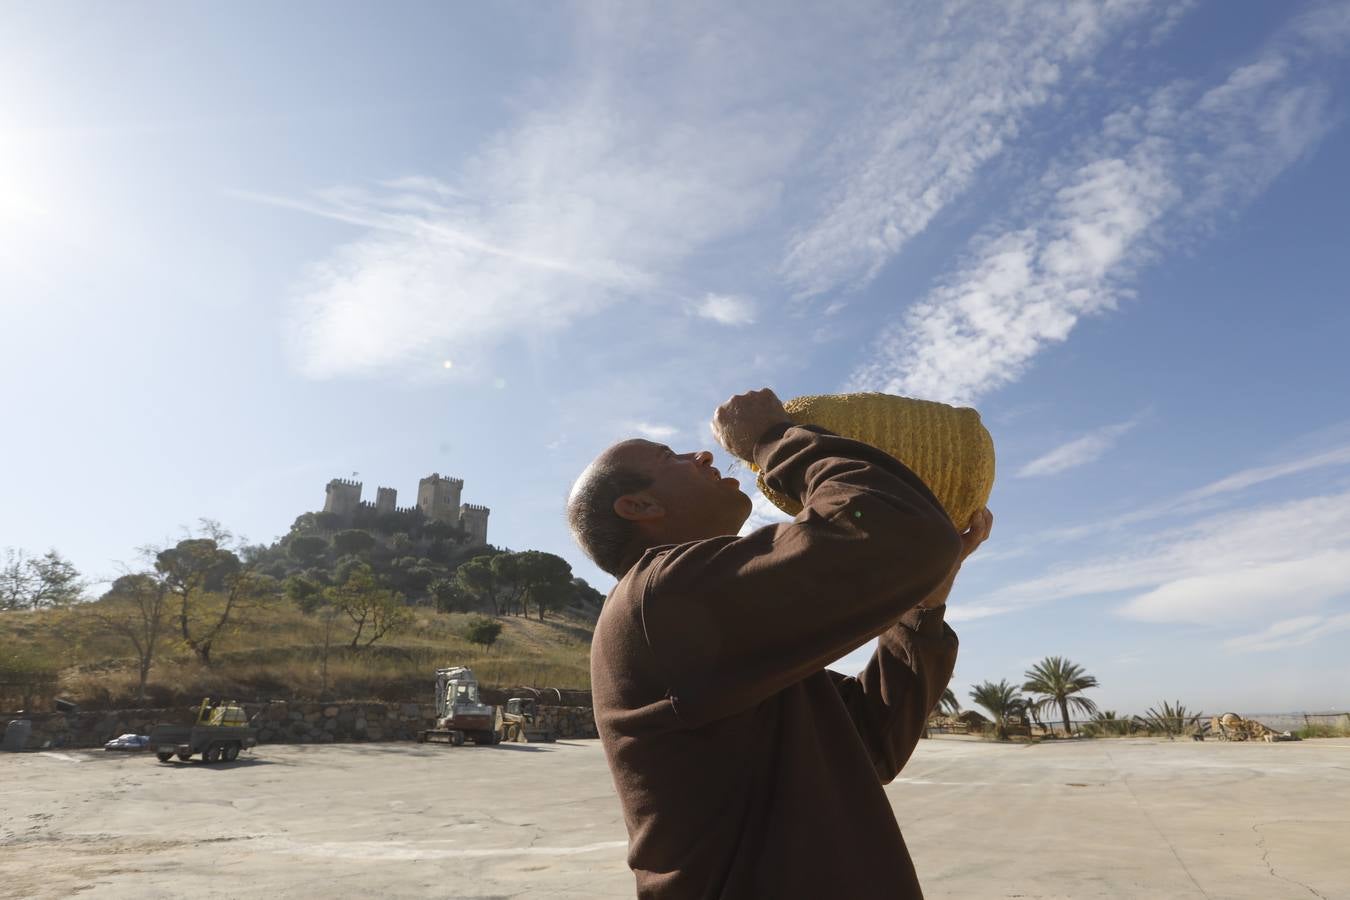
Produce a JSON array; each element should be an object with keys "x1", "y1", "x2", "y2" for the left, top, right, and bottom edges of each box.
[{"x1": 782, "y1": 0, "x2": 1150, "y2": 296}]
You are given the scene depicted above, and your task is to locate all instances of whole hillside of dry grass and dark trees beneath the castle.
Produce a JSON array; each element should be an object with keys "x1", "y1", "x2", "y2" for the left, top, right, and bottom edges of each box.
[{"x1": 0, "y1": 511, "x2": 603, "y2": 710}]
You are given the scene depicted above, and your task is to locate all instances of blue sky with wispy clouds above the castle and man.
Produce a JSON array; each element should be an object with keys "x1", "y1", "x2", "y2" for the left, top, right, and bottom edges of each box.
[{"x1": 0, "y1": 0, "x2": 1350, "y2": 712}]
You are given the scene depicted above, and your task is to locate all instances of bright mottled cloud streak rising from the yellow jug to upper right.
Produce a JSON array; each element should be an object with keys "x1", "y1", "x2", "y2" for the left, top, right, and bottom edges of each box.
[{"x1": 849, "y1": 6, "x2": 1345, "y2": 403}]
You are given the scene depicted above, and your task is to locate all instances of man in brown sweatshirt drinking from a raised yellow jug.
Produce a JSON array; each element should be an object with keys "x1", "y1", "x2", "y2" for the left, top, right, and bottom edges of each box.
[{"x1": 568, "y1": 389, "x2": 992, "y2": 900}]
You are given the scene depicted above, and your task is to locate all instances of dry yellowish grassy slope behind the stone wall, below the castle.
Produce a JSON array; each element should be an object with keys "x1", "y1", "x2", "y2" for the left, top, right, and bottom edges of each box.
[{"x1": 0, "y1": 602, "x2": 591, "y2": 708}]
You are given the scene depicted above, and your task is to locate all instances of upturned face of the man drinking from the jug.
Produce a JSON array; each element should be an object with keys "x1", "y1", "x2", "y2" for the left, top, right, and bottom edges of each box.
[{"x1": 614, "y1": 440, "x2": 751, "y2": 542}]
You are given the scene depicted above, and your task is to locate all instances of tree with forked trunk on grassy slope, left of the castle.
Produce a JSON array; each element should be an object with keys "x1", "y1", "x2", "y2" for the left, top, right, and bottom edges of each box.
[{"x1": 154, "y1": 531, "x2": 273, "y2": 665}]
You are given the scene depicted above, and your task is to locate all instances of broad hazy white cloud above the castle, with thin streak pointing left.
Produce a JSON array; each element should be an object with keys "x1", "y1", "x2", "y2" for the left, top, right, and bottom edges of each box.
[{"x1": 236, "y1": 24, "x2": 805, "y2": 379}]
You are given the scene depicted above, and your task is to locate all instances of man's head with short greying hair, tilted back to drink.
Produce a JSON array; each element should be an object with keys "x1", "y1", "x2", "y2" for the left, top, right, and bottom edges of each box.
[{"x1": 567, "y1": 439, "x2": 751, "y2": 578}]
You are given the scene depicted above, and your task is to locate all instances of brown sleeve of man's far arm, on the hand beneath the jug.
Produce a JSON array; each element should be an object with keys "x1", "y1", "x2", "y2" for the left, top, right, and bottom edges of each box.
[{"x1": 829, "y1": 607, "x2": 957, "y2": 784}]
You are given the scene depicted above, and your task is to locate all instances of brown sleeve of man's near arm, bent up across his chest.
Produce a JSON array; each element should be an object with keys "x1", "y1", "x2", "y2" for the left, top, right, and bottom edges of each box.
[{"x1": 639, "y1": 424, "x2": 961, "y2": 727}]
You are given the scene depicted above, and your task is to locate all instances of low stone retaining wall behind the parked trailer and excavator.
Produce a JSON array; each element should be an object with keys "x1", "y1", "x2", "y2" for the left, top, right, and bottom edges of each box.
[{"x1": 0, "y1": 702, "x2": 597, "y2": 750}]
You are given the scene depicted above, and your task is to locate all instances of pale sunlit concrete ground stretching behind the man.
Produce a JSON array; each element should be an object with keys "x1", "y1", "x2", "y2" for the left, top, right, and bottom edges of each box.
[{"x1": 0, "y1": 738, "x2": 1350, "y2": 900}]
